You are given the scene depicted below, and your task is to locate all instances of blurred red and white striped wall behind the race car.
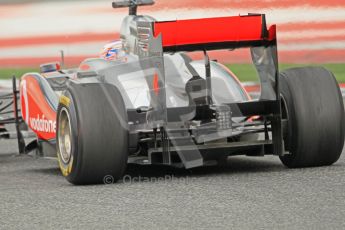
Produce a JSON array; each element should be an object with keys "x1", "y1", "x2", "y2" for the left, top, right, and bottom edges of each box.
[{"x1": 0, "y1": 0, "x2": 345, "y2": 67}]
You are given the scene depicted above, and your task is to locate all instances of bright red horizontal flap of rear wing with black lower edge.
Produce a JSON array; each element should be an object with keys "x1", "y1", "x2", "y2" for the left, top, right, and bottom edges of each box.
[{"x1": 152, "y1": 14, "x2": 276, "y2": 52}]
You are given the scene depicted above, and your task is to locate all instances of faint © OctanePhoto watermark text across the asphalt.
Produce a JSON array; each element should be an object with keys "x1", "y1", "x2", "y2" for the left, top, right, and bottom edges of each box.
[{"x1": 103, "y1": 175, "x2": 190, "y2": 184}]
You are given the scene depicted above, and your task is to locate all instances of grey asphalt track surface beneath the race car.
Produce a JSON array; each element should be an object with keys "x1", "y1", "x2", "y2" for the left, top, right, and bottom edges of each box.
[{"x1": 0, "y1": 136, "x2": 345, "y2": 229}]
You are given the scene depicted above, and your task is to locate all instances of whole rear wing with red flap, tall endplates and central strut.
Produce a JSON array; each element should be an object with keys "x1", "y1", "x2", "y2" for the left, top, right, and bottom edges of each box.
[{"x1": 134, "y1": 14, "x2": 280, "y2": 121}]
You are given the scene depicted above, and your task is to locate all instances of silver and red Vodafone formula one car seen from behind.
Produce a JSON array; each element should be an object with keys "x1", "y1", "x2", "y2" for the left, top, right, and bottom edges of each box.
[{"x1": 3, "y1": 0, "x2": 345, "y2": 184}]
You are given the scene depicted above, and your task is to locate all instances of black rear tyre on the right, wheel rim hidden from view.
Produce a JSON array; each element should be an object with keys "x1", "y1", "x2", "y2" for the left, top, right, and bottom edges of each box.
[{"x1": 280, "y1": 67, "x2": 345, "y2": 168}]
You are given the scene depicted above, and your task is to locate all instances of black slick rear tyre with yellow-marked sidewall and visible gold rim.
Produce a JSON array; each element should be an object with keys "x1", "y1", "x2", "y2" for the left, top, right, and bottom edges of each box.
[{"x1": 56, "y1": 82, "x2": 128, "y2": 184}]
